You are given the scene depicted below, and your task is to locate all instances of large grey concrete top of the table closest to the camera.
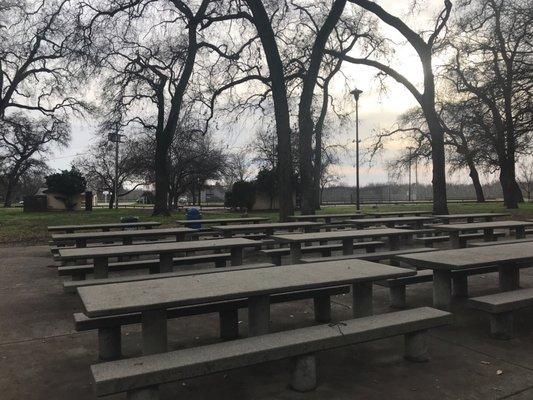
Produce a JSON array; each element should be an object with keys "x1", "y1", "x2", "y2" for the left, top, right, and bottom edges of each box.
[{"x1": 78, "y1": 260, "x2": 415, "y2": 317}]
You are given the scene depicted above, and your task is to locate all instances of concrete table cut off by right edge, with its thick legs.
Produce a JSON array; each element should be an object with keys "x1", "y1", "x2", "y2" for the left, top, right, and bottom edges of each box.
[{"x1": 395, "y1": 243, "x2": 533, "y2": 309}]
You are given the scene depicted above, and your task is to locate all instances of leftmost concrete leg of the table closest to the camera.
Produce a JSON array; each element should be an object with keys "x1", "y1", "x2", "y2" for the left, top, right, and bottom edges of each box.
[{"x1": 141, "y1": 310, "x2": 167, "y2": 355}]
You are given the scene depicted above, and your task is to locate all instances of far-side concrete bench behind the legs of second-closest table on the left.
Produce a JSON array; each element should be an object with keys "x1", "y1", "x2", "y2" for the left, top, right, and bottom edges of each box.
[{"x1": 57, "y1": 253, "x2": 231, "y2": 280}]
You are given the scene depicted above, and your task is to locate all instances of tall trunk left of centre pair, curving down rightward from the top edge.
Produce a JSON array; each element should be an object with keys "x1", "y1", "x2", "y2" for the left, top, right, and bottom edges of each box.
[{"x1": 246, "y1": 0, "x2": 294, "y2": 221}]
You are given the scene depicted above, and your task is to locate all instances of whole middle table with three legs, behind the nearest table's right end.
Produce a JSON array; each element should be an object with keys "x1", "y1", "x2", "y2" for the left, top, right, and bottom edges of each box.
[{"x1": 271, "y1": 228, "x2": 413, "y2": 264}]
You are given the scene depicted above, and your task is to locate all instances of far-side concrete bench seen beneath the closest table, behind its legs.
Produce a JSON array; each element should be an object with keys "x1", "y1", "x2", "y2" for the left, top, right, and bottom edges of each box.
[{"x1": 74, "y1": 286, "x2": 350, "y2": 360}]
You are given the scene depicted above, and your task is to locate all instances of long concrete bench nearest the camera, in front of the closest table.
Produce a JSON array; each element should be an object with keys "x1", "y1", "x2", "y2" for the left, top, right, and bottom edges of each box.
[{"x1": 91, "y1": 307, "x2": 452, "y2": 400}]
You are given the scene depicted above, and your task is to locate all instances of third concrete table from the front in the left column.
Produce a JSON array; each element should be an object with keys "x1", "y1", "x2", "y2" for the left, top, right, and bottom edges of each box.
[{"x1": 52, "y1": 228, "x2": 196, "y2": 247}]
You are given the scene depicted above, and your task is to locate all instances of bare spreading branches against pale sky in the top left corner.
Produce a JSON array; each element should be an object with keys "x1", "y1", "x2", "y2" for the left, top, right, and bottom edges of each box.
[{"x1": 0, "y1": 0, "x2": 87, "y2": 119}]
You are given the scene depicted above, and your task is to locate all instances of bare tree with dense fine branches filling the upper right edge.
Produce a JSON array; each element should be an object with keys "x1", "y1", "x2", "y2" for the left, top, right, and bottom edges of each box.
[{"x1": 447, "y1": 0, "x2": 533, "y2": 208}]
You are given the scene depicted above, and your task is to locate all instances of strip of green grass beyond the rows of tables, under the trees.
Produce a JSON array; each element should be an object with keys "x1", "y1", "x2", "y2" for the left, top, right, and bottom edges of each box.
[{"x1": 0, "y1": 202, "x2": 533, "y2": 246}]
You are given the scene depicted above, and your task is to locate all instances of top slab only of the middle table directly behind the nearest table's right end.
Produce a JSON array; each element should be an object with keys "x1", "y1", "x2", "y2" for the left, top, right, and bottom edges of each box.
[{"x1": 271, "y1": 228, "x2": 416, "y2": 242}]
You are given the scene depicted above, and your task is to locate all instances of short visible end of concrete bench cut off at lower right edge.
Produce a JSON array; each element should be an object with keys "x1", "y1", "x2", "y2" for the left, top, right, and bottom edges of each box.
[{"x1": 468, "y1": 288, "x2": 533, "y2": 340}]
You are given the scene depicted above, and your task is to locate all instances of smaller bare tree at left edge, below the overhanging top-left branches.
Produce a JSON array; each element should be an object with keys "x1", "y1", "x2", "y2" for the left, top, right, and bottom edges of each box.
[{"x1": 0, "y1": 113, "x2": 70, "y2": 207}]
